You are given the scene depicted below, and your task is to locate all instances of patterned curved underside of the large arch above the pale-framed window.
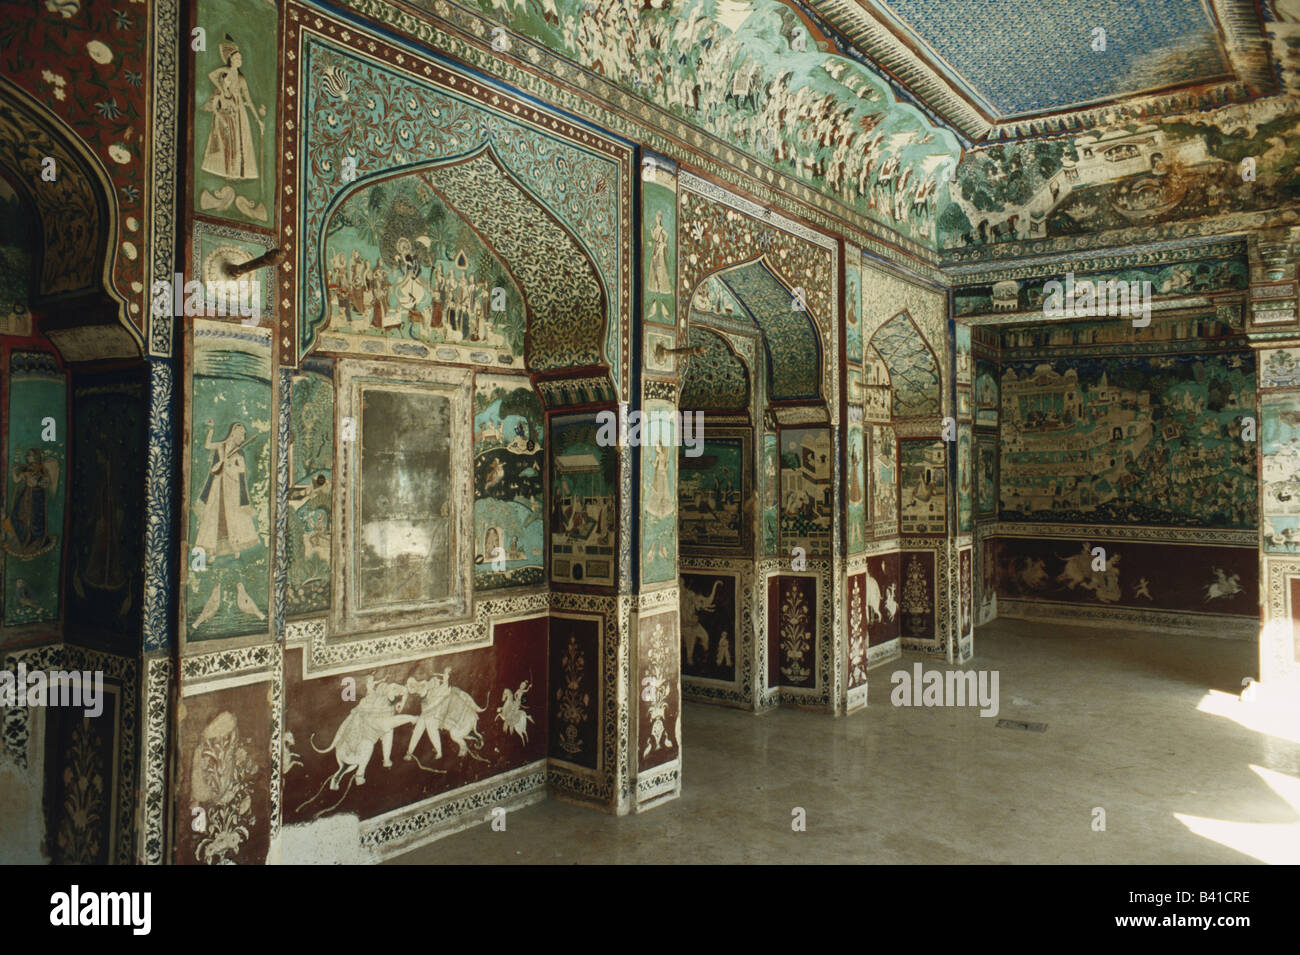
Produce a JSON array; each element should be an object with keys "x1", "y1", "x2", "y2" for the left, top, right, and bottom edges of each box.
[{"x1": 310, "y1": 144, "x2": 608, "y2": 372}]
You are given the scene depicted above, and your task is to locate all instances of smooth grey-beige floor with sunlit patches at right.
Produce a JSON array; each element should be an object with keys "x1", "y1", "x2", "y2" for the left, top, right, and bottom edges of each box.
[{"x1": 394, "y1": 620, "x2": 1300, "y2": 864}]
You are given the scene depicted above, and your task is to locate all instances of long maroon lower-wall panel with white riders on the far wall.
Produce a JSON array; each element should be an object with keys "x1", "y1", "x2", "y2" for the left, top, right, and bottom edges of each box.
[{"x1": 996, "y1": 538, "x2": 1260, "y2": 617}]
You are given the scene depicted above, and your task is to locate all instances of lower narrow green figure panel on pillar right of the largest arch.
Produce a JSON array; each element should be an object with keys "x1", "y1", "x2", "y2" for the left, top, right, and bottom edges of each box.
[{"x1": 638, "y1": 399, "x2": 685, "y2": 583}]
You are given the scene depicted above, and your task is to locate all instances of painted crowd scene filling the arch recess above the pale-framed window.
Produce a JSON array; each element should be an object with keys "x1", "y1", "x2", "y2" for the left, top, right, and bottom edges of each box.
[{"x1": 324, "y1": 173, "x2": 524, "y2": 368}]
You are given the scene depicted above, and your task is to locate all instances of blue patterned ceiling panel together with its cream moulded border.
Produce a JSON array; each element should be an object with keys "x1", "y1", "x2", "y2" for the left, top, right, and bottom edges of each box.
[{"x1": 807, "y1": 0, "x2": 1274, "y2": 144}]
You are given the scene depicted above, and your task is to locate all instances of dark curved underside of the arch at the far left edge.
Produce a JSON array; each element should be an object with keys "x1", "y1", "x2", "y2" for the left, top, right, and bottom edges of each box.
[{"x1": 0, "y1": 77, "x2": 143, "y2": 361}]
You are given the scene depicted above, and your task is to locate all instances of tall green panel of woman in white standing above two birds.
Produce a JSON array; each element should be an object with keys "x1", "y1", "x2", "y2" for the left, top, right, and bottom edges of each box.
[{"x1": 182, "y1": 321, "x2": 272, "y2": 641}]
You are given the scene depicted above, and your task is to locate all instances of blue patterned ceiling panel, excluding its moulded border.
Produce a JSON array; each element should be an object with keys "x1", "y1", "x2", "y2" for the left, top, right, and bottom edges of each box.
[{"x1": 872, "y1": 0, "x2": 1231, "y2": 118}]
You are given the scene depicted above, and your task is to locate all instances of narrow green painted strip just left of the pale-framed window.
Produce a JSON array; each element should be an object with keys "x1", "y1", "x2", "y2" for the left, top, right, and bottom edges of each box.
[{"x1": 285, "y1": 359, "x2": 334, "y2": 617}]
